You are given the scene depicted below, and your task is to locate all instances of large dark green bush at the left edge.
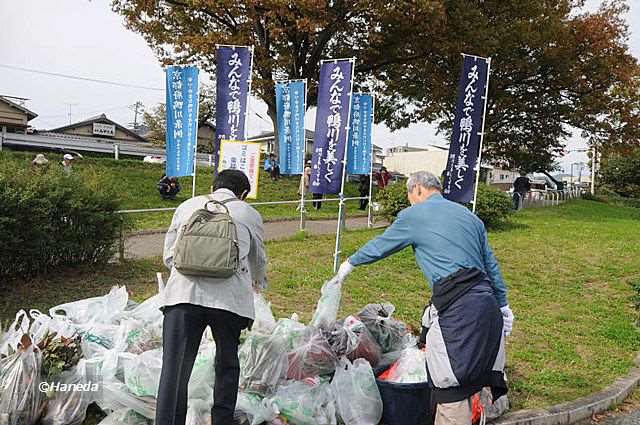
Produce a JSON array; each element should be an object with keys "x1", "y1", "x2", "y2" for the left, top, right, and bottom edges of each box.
[{"x1": 0, "y1": 164, "x2": 120, "y2": 281}]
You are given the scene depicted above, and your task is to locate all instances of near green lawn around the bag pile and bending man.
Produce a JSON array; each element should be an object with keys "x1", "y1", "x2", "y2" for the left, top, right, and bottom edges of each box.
[{"x1": 0, "y1": 201, "x2": 640, "y2": 409}]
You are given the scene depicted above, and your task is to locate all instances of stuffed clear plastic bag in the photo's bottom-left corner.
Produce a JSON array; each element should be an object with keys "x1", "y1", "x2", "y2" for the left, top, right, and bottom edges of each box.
[{"x1": 0, "y1": 336, "x2": 44, "y2": 425}]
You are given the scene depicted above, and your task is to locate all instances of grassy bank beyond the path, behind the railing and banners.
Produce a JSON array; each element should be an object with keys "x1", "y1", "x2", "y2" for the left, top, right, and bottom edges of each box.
[{"x1": 0, "y1": 149, "x2": 363, "y2": 230}]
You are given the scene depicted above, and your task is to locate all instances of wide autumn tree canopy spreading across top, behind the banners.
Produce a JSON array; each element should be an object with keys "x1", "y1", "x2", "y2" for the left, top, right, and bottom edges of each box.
[{"x1": 112, "y1": 0, "x2": 640, "y2": 172}]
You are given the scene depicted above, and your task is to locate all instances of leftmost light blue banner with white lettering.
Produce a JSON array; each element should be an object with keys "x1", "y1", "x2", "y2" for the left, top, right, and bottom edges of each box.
[{"x1": 165, "y1": 66, "x2": 198, "y2": 177}]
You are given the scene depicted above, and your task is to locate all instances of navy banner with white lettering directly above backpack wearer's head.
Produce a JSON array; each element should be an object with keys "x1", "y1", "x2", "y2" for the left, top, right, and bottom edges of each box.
[{"x1": 214, "y1": 46, "x2": 253, "y2": 143}]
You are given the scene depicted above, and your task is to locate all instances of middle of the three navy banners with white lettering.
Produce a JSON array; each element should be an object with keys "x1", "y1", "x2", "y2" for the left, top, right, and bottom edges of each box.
[{"x1": 309, "y1": 59, "x2": 353, "y2": 194}]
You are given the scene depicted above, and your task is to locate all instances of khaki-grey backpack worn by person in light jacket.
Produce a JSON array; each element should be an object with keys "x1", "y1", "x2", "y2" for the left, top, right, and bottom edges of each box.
[{"x1": 173, "y1": 199, "x2": 240, "y2": 278}]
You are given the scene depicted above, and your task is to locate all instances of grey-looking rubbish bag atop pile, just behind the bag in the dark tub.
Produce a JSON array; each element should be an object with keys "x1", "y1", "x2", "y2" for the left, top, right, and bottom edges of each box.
[{"x1": 358, "y1": 303, "x2": 409, "y2": 353}]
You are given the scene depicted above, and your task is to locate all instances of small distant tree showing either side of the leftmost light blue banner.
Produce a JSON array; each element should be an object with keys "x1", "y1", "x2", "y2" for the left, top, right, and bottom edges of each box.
[{"x1": 142, "y1": 84, "x2": 216, "y2": 146}]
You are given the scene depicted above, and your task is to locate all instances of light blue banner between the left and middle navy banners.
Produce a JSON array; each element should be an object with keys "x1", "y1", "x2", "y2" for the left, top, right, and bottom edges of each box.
[{"x1": 276, "y1": 81, "x2": 307, "y2": 174}]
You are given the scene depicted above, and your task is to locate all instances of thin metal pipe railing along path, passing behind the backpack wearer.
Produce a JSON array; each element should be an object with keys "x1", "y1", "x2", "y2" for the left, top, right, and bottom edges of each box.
[{"x1": 117, "y1": 196, "x2": 373, "y2": 261}]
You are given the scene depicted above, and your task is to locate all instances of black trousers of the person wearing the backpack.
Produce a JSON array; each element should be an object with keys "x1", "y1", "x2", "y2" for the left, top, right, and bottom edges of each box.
[{"x1": 156, "y1": 304, "x2": 251, "y2": 425}]
